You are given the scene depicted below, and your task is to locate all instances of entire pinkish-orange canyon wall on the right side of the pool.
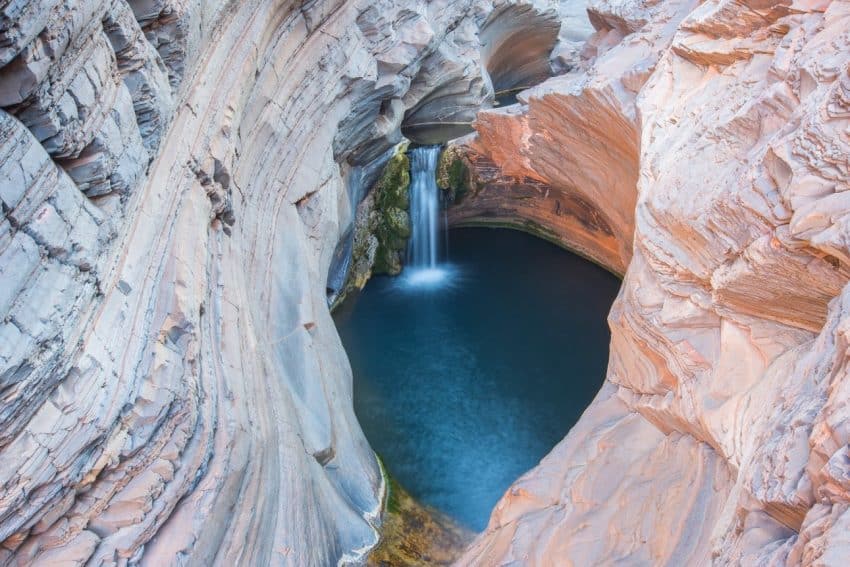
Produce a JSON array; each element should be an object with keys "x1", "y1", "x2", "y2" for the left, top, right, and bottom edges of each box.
[{"x1": 459, "y1": 0, "x2": 850, "y2": 565}]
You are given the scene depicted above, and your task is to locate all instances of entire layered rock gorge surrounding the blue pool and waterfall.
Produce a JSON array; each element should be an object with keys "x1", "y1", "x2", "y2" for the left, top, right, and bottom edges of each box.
[{"x1": 0, "y1": 0, "x2": 850, "y2": 566}]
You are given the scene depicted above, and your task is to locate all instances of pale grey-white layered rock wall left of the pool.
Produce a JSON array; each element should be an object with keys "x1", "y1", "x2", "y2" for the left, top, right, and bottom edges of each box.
[{"x1": 0, "y1": 0, "x2": 560, "y2": 566}]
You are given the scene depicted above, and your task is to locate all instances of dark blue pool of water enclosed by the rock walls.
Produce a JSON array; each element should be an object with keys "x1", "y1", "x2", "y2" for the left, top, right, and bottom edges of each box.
[{"x1": 335, "y1": 228, "x2": 619, "y2": 530}]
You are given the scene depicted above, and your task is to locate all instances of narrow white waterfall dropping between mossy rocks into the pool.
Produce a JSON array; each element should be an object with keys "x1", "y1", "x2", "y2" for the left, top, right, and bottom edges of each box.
[{"x1": 405, "y1": 146, "x2": 448, "y2": 285}]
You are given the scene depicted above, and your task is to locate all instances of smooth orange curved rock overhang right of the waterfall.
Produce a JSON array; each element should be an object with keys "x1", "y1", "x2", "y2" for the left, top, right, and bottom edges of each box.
[{"x1": 450, "y1": 3, "x2": 664, "y2": 274}]
